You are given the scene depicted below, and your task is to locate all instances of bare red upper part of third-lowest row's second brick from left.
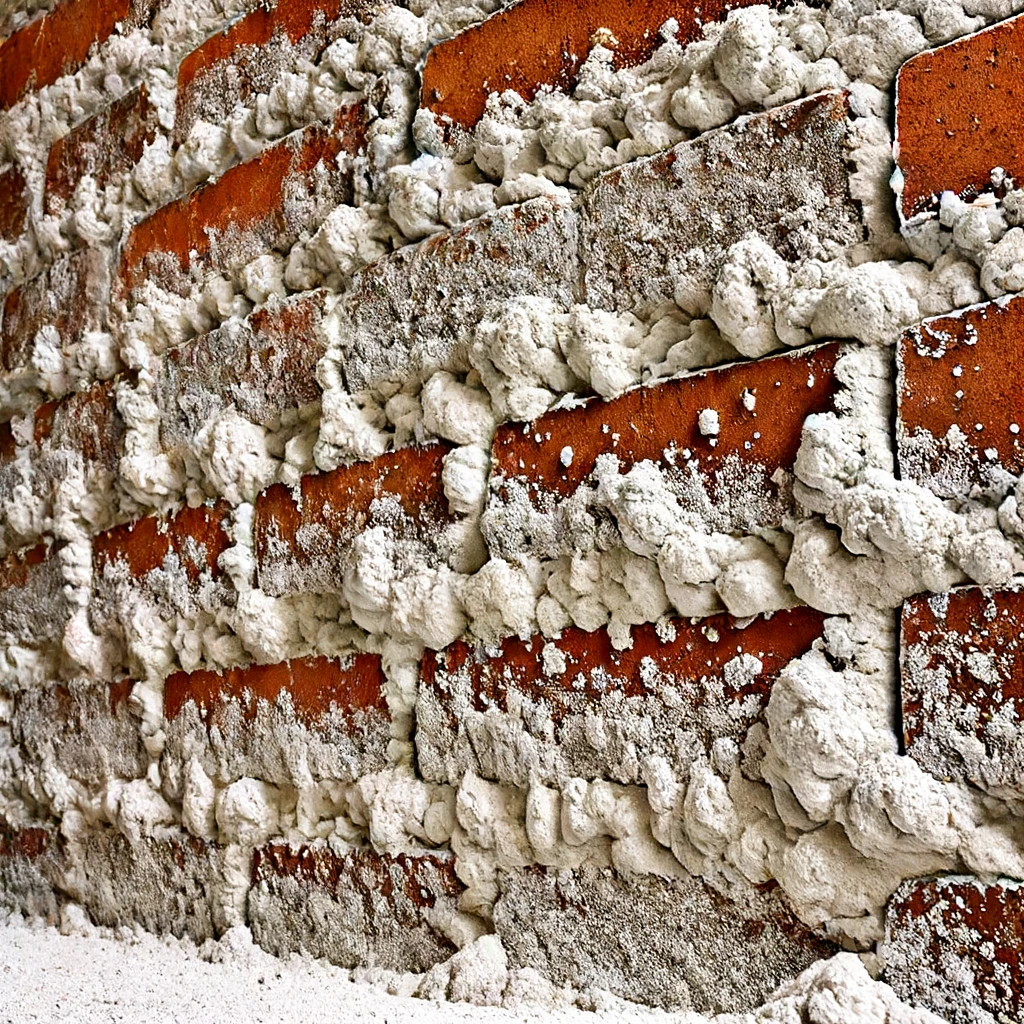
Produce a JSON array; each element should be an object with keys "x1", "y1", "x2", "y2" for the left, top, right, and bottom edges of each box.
[{"x1": 92, "y1": 502, "x2": 230, "y2": 583}]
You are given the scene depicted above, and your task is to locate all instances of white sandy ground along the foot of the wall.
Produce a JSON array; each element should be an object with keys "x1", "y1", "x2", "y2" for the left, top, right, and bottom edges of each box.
[{"x1": 0, "y1": 923, "x2": 614, "y2": 1024}]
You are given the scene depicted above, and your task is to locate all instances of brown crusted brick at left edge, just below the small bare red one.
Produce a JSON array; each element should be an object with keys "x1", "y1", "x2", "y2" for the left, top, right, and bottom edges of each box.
[{"x1": 0, "y1": 249, "x2": 110, "y2": 373}]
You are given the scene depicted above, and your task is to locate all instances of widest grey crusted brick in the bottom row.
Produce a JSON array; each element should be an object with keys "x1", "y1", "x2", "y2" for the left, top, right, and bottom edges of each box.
[{"x1": 495, "y1": 867, "x2": 837, "y2": 1016}]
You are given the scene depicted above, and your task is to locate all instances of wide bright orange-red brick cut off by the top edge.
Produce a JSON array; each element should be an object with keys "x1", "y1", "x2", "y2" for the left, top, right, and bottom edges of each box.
[{"x1": 421, "y1": 0, "x2": 765, "y2": 128}]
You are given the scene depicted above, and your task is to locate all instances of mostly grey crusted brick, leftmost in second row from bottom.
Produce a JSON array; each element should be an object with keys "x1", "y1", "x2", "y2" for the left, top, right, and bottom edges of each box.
[{"x1": 11, "y1": 679, "x2": 150, "y2": 785}]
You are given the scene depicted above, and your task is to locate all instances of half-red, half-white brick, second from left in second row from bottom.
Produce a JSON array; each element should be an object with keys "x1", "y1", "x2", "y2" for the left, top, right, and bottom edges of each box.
[{"x1": 164, "y1": 654, "x2": 391, "y2": 785}]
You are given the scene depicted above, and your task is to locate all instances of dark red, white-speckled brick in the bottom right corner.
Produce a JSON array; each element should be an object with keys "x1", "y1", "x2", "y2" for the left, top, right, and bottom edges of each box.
[{"x1": 880, "y1": 876, "x2": 1024, "y2": 1024}]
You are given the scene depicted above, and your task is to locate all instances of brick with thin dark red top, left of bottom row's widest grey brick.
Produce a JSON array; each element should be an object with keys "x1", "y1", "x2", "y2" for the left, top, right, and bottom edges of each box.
[{"x1": 249, "y1": 844, "x2": 464, "y2": 972}]
